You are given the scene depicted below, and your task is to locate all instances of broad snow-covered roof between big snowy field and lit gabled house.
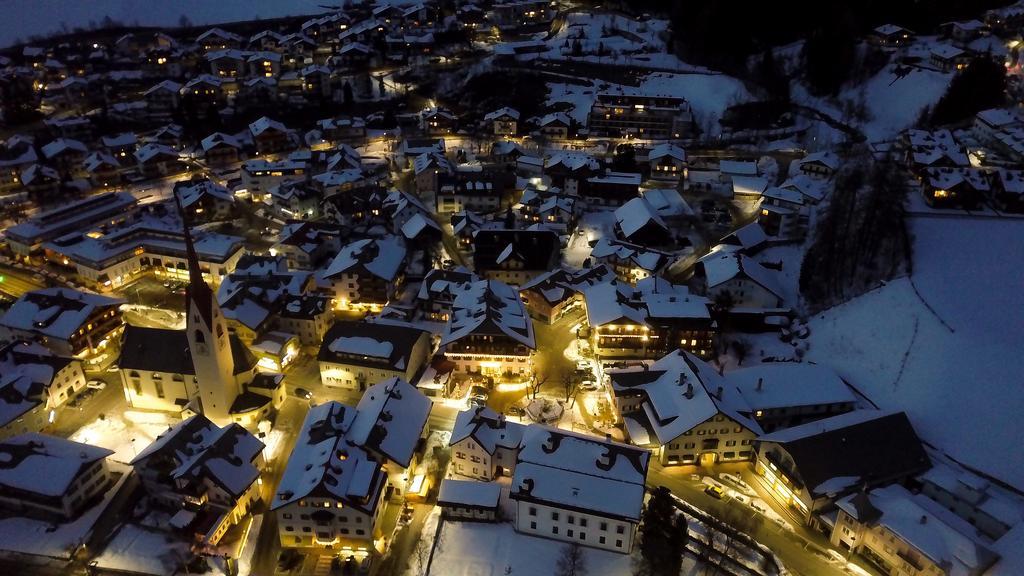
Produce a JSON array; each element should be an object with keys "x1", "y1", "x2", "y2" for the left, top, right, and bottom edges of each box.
[{"x1": 728, "y1": 362, "x2": 857, "y2": 410}]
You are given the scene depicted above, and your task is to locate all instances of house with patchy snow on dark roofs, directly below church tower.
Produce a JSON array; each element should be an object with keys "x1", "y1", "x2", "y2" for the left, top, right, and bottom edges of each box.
[{"x1": 131, "y1": 414, "x2": 264, "y2": 546}]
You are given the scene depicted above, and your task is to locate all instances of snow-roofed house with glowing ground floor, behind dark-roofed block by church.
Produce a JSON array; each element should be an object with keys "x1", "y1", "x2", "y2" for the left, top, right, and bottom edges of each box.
[{"x1": 324, "y1": 236, "x2": 407, "y2": 310}]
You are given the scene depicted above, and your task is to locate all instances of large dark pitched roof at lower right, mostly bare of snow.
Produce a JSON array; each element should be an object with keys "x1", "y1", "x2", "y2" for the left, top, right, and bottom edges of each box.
[{"x1": 759, "y1": 410, "x2": 931, "y2": 495}]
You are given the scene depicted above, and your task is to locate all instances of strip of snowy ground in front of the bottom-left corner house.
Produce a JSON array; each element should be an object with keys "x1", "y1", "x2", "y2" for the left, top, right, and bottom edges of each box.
[{"x1": 0, "y1": 462, "x2": 131, "y2": 559}]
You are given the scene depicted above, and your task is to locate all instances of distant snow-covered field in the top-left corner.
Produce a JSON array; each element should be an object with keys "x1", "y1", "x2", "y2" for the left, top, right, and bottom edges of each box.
[{"x1": 0, "y1": 0, "x2": 330, "y2": 46}]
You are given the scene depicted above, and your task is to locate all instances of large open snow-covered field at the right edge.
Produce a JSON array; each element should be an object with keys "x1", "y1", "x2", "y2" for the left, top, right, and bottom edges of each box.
[{"x1": 808, "y1": 217, "x2": 1024, "y2": 488}]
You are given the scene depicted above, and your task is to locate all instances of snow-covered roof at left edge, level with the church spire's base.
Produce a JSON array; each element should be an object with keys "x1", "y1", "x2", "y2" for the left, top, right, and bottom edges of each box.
[{"x1": 0, "y1": 288, "x2": 124, "y2": 339}]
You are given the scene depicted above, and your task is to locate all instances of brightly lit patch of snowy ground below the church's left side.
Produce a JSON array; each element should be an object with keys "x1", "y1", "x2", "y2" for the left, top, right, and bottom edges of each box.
[{"x1": 71, "y1": 410, "x2": 176, "y2": 462}]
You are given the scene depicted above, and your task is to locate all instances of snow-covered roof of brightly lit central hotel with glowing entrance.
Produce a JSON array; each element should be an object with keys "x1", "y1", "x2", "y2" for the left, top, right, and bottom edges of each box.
[{"x1": 441, "y1": 280, "x2": 537, "y2": 348}]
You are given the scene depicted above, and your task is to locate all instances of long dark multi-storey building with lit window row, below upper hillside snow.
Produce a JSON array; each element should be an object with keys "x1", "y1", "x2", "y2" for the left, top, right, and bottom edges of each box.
[{"x1": 588, "y1": 92, "x2": 693, "y2": 139}]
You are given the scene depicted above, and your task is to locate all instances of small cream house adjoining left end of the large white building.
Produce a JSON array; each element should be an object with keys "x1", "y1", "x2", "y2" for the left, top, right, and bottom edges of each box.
[{"x1": 449, "y1": 406, "x2": 526, "y2": 482}]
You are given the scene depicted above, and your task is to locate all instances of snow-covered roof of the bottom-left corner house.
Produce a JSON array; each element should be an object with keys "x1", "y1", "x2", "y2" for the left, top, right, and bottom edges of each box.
[{"x1": 0, "y1": 433, "x2": 114, "y2": 498}]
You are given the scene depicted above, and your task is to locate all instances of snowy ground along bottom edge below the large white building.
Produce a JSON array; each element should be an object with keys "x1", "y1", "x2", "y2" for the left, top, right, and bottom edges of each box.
[{"x1": 430, "y1": 522, "x2": 700, "y2": 576}]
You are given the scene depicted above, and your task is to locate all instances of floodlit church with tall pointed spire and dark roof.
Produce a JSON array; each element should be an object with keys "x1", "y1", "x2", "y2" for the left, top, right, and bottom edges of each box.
[{"x1": 118, "y1": 206, "x2": 285, "y2": 429}]
